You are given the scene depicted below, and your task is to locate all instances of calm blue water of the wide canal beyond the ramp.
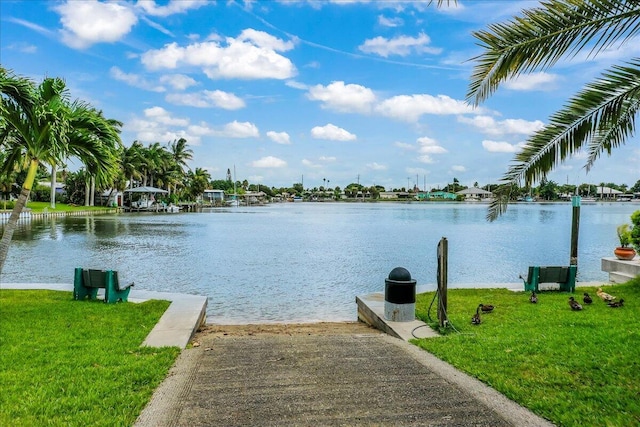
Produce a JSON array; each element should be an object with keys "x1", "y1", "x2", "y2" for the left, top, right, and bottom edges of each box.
[{"x1": 2, "y1": 203, "x2": 640, "y2": 323}]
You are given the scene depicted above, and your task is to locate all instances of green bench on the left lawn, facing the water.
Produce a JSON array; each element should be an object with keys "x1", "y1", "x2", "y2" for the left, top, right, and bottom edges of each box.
[{"x1": 73, "y1": 267, "x2": 133, "y2": 303}]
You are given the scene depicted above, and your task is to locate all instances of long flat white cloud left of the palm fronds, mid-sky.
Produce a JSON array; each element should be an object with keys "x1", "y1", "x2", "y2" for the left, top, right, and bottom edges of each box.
[{"x1": 376, "y1": 95, "x2": 478, "y2": 122}]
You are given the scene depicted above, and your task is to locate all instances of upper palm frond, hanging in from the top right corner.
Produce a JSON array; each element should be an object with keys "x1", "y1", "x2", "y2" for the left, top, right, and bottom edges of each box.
[{"x1": 467, "y1": 0, "x2": 640, "y2": 105}]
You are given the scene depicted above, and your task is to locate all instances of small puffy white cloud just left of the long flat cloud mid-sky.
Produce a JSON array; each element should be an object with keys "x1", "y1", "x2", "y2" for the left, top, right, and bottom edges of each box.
[{"x1": 307, "y1": 81, "x2": 376, "y2": 114}]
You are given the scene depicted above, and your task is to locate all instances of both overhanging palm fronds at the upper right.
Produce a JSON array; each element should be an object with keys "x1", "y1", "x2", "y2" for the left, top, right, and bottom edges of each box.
[{"x1": 467, "y1": 0, "x2": 640, "y2": 221}]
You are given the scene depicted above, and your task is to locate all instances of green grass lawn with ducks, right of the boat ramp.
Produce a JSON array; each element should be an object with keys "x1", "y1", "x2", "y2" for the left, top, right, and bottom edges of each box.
[{"x1": 413, "y1": 279, "x2": 640, "y2": 427}]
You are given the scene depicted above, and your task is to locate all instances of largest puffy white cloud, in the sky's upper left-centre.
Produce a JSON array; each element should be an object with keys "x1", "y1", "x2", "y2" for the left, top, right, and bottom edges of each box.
[{"x1": 141, "y1": 29, "x2": 296, "y2": 80}]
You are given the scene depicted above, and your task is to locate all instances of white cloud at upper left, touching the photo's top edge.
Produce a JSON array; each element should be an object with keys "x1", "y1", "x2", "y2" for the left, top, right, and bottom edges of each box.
[{"x1": 54, "y1": 1, "x2": 138, "y2": 49}]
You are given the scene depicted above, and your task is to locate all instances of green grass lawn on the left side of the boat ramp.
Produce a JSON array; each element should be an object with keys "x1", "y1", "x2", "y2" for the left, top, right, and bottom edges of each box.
[{"x1": 0, "y1": 289, "x2": 180, "y2": 426}]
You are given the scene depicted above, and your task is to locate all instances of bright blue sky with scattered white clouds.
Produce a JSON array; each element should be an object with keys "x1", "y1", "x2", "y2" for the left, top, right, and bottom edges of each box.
[{"x1": 0, "y1": 0, "x2": 640, "y2": 190}]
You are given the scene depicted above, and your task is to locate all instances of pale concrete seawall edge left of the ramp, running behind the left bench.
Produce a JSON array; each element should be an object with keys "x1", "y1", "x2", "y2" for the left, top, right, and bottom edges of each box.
[{"x1": 0, "y1": 283, "x2": 207, "y2": 349}]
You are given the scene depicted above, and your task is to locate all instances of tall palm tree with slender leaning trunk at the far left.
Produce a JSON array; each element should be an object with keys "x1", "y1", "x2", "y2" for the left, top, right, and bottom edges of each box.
[{"x1": 0, "y1": 67, "x2": 121, "y2": 274}]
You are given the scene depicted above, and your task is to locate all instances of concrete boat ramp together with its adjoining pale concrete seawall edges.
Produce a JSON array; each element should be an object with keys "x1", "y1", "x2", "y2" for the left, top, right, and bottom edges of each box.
[{"x1": 2, "y1": 284, "x2": 552, "y2": 427}]
